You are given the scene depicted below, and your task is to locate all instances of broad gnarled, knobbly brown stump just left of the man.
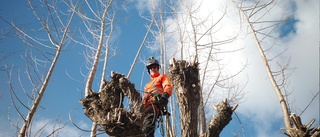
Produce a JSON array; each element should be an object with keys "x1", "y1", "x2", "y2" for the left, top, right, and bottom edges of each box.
[{"x1": 79, "y1": 73, "x2": 143, "y2": 137}]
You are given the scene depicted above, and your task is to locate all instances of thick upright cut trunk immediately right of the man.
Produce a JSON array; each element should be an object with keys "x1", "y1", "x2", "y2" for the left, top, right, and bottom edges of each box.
[{"x1": 168, "y1": 59, "x2": 200, "y2": 137}]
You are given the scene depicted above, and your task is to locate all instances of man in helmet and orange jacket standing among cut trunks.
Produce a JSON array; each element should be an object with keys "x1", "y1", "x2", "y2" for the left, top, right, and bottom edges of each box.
[{"x1": 142, "y1": 57, "x2": 172, "y2": 137}]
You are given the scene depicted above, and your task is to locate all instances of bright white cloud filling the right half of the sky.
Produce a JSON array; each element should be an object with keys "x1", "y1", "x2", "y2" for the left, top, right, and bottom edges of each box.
[{"x1": 145, "y1": 0, "x2": 320, "y2": 137}]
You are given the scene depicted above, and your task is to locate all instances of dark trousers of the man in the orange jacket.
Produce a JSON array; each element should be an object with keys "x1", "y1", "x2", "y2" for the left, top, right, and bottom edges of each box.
[{"x1": 142, "y1": 104, "x2": 159, "y2": 137}]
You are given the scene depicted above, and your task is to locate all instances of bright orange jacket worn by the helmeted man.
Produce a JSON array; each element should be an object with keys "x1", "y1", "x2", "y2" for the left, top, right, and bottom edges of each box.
[{"x1": 143, "y1": 74, "x2": 172, "y2": 105}]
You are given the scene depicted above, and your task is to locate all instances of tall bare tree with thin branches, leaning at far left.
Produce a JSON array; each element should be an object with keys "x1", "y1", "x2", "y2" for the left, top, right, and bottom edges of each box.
[{"x1": 7, "y1": 1, "x2": 75, "y2": 137}]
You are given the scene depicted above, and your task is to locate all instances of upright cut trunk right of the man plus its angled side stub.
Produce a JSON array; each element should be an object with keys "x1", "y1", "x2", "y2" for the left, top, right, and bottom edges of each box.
[{"x1": 168, "y1": 58, "x2": 238, "y2": 137}]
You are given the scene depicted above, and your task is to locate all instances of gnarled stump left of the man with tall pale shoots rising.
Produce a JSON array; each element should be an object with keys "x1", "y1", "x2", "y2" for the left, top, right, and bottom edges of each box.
[{"x1": 73, "y1": 0, "x2": 149, "y2": 137}]
